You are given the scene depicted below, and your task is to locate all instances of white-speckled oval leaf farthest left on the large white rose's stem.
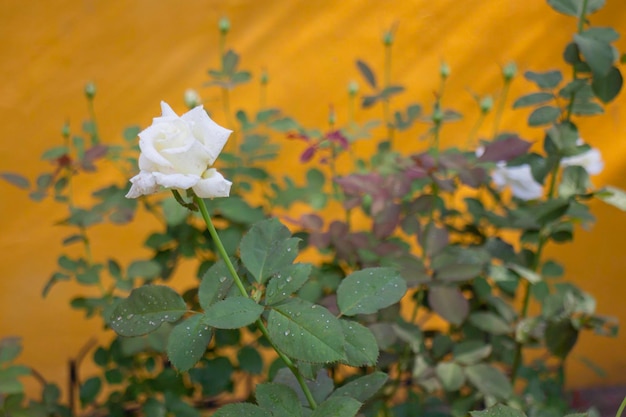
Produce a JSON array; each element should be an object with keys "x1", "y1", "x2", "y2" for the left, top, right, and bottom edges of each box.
[{"x1": 109, "y1": 285, "x2": 187, "y2": 336}]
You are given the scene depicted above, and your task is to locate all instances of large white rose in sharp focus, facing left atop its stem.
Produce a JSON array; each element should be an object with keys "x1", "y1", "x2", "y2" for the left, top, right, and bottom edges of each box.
[{"x1": 126, "y1": 101, "x2": 232, "y2": 198}]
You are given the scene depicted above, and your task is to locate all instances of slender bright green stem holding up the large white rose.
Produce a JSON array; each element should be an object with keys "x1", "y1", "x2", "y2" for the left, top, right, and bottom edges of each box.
[{"x1": 193, "y1": 196, "x2": 317, "y2": 410}]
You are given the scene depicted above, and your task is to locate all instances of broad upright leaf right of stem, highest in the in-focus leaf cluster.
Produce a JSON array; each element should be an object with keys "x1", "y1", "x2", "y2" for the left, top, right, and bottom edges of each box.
[{"x1": 239, "y1": 218, "x2": 300, "y2": 283}]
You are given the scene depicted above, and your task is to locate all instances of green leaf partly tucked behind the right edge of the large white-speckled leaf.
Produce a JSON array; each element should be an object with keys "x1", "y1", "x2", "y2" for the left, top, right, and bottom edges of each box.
[{"x1": 339, "y1": 319, "x2": 378, "y2": 367}]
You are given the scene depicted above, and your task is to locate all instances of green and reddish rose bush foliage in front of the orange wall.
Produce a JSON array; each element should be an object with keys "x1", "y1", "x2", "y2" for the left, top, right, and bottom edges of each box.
[{"x1": 0, "y1": 0, "x2": 626, "y2": 417}]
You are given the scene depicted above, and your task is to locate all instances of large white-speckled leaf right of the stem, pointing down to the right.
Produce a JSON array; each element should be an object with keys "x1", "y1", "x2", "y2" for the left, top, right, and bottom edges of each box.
[{"x1": 267, "y1": 298, "x2": 347, "y2": 363}]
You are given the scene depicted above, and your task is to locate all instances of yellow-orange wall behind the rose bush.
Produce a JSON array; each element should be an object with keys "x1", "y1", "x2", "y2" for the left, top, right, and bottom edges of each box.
[{"x1": 0, "y1": 0, "x2": 626, "y2": 386}]
